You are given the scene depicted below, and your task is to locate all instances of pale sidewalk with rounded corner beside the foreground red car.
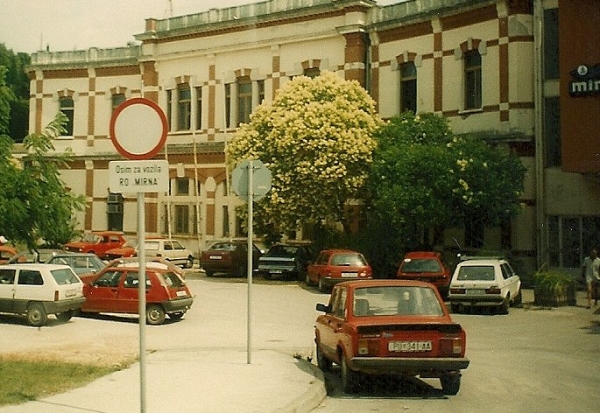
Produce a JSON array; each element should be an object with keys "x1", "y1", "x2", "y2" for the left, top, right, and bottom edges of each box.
[{"x1": 0, "y1": 350, "x2": 326, "y2": 413}]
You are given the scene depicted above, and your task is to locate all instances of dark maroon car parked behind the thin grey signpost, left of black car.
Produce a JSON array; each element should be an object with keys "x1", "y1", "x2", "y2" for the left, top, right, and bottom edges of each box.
[{"x1": 200, "y1": 241, "x2": 262, "y2": 277}]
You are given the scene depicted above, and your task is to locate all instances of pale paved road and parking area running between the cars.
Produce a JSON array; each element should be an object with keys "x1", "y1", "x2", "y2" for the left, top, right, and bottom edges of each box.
[{"x1": 0, "y1": 274, "x2": 600, "y2": 413}]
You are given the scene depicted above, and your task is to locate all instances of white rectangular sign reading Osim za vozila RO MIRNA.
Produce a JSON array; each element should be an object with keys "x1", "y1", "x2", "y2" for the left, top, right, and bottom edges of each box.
[{"x1": 108, "y1": 160, "x2": 169, "y2": 194}]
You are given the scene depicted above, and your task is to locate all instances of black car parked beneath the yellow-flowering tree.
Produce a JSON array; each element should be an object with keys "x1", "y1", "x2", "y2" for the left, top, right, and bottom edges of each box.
[{"x1": 257, "y1": 244, "x2": 313, "y2": 280}]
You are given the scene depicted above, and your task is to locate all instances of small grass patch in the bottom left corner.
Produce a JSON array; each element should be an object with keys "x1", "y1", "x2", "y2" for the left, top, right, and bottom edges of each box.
[{"x1": 0, "y1": 357, "x2": 130, "y2": 406}]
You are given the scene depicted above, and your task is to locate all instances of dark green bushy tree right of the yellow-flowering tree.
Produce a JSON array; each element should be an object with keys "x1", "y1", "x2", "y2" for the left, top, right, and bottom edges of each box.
[{"x1": 368, "y1": 112, "x2": 525, "y2": 273}]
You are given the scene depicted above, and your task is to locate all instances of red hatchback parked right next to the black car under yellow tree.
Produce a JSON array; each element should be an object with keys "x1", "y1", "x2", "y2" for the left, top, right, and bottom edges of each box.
[{"x1": 306, "y1": 249, "x2": 373, "y2": 292}]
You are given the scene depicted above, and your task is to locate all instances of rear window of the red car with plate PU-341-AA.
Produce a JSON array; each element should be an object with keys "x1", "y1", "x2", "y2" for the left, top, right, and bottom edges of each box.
[{"x1": 353, "y1": 287, "x2": 444, "y2": 317}]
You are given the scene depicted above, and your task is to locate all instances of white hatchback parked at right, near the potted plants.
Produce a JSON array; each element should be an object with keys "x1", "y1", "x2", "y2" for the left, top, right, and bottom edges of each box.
[{"x1": 448, "y1": 257, "x2": 521, "y2": 314}]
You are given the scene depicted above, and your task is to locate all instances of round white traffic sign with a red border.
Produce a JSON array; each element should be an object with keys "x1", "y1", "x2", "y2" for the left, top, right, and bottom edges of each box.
[{"x1": 109, "y1": 98, "x2": 168, "y2": 159}]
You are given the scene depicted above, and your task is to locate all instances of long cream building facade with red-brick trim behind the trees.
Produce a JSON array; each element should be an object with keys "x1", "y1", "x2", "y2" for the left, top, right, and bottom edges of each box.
[{"x1": 21, "y1": 0, "x2": 600, "y2": 276}]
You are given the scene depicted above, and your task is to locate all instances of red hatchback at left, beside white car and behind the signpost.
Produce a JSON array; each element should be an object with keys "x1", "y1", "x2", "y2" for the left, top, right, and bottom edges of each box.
[{"x1": 81, "y1": 260, "x2": 194, "y2": 325}]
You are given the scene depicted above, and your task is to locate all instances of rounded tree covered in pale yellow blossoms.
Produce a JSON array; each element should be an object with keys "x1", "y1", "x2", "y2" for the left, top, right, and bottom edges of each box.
[{"x1": 226, "y1": 72, "x2": 381, "y2": 235}]
